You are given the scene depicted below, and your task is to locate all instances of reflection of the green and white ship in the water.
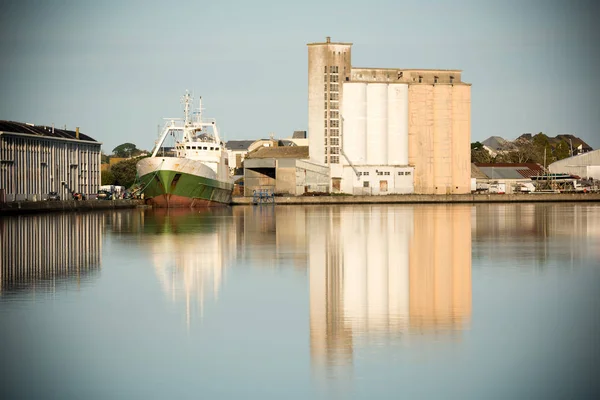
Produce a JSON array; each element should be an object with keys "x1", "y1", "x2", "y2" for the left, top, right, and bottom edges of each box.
[{"x1": 142, "y1": 207, "x2": 236, "y2": 327}]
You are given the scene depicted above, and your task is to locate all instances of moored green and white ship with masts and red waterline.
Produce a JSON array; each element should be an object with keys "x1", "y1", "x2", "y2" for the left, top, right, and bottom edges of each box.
[{"x1": 136, "y1": 92, "x2": 233, "y2": 208}]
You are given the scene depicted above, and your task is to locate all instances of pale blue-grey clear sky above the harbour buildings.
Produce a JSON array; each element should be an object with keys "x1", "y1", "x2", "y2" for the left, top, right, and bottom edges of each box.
[{"x1": 0, "y1": 0, "x2": 600, "y2": 154}]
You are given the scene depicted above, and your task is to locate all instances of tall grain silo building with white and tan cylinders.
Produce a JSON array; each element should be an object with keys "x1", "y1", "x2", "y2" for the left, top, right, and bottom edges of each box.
[{"x1": 308, "y1": 37, "x2": 471, "y2": 194}]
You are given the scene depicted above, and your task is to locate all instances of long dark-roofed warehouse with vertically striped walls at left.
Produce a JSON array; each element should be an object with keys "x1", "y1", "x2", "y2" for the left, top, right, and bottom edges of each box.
[{"x1": 0, "y1": 121, "x2": 102, "y2": 202}]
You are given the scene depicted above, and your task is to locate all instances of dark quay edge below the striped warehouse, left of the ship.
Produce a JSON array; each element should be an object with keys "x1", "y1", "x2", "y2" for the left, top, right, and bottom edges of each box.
[{"x1": 0, "y1": 200, "x2": 144, "y2": 216}]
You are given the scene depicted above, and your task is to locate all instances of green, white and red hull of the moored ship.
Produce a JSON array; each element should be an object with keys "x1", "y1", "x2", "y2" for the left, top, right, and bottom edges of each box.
[{"x1": 137, "y1": 157, "x2": 233, "y2": 208}]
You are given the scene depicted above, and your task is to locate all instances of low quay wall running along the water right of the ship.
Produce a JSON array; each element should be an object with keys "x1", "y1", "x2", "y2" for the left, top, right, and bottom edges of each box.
[{"x1": 231, "y1": 193, "x2": 600, "y2": 205}]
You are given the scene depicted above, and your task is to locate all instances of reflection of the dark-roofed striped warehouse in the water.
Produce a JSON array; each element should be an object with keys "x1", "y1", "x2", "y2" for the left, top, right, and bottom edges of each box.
[{"x1": 0, "y1": 213, "x2": 103, "y2": 294}]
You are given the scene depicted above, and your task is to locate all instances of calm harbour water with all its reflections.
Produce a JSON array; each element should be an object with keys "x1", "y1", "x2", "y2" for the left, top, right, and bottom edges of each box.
[{"x1": 0, "y1": 203, "x2": 600, "y2": 399}]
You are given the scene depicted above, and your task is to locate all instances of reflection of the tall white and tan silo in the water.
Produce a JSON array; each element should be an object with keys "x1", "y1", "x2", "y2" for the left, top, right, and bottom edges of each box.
[{"x1": 306, "y1": 205, "x2": 472, "y2": 372}]
